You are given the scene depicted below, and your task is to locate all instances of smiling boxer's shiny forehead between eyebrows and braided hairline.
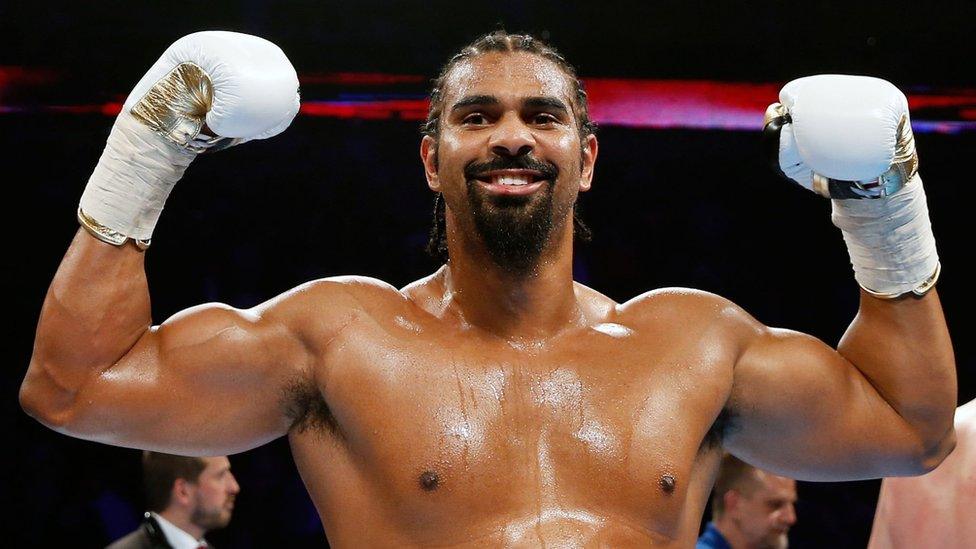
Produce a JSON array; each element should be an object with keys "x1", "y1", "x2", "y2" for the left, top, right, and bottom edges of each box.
[{"x1": 444, "y1": 52, "x2": 574, "y2": 105}]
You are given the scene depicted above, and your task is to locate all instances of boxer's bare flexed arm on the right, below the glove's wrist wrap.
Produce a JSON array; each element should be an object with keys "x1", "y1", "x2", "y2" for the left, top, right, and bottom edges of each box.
[{"x1": 724, "y1": 290, "x2": 956, "y2": 480}]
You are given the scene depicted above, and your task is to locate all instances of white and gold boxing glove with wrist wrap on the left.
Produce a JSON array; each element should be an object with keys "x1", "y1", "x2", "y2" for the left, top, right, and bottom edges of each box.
[{"x1": 78, "y1": 31, "x2": 299, "y2": 247}]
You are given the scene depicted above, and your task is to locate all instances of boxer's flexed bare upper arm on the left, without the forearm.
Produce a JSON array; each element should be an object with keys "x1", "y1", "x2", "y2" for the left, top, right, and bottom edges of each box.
[{"x1": 55, "y1": 298, "x2": 312, "y2": 455}]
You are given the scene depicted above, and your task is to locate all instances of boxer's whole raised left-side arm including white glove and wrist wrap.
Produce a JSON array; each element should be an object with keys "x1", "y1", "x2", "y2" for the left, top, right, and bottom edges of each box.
[{"x1": 20, "y1": 32, "x2": 336, "y2": 454}]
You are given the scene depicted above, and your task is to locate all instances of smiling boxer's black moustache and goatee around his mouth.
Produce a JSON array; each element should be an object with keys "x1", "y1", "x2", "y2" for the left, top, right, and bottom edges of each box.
[{"x1": 465, "y1": 156, "x2": 558, "y2": 276}]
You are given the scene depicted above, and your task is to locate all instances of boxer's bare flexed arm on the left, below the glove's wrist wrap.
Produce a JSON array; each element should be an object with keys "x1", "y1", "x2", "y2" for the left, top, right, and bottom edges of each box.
[{"x1": 20, "y1": 231, "x2": 358, "y2": 455}]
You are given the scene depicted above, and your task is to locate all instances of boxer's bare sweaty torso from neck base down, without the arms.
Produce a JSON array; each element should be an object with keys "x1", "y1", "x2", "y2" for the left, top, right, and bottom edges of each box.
[{"x1": 283, "y1": 268, "x2": 738, "y2": 547}]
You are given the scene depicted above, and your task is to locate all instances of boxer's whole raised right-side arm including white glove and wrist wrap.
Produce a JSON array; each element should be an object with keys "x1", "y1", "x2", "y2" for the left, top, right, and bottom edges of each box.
[{"x1": 725, "y1": 75, "x2": 956, "y2": 480}]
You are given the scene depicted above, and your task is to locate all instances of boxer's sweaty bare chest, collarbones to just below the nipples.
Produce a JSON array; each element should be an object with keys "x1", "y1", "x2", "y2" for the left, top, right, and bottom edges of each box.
[{"x1": 312, "y1": 316, "x2": 724, "y2": 532}]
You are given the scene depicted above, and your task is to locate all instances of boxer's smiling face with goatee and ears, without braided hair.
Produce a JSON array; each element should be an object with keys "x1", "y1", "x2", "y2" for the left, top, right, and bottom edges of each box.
[{"x1": 421, "y1": 52, "x2": 597, "y2": 273}]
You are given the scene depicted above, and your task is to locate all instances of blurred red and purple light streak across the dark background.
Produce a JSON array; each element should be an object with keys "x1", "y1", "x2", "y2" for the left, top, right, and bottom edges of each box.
[{"x1": 0, "y1": 66, "x2": 976, "y2": 132}]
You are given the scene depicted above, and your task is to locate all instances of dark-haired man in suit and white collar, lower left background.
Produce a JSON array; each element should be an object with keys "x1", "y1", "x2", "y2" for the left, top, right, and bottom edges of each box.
[{"x1": 108, "y1": 452, "x2": 241, "y2": 549}]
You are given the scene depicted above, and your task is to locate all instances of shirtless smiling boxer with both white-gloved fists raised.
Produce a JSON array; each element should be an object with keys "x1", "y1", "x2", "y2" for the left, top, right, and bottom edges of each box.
[{"x1": 20, "y1": 33, "x2": 956, "y2": 547}]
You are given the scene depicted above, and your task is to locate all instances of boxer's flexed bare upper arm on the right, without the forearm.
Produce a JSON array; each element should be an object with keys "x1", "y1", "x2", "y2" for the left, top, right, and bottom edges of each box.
[{"x1": 724, "y1": 328, "x2": 936, "y2": 480}]
